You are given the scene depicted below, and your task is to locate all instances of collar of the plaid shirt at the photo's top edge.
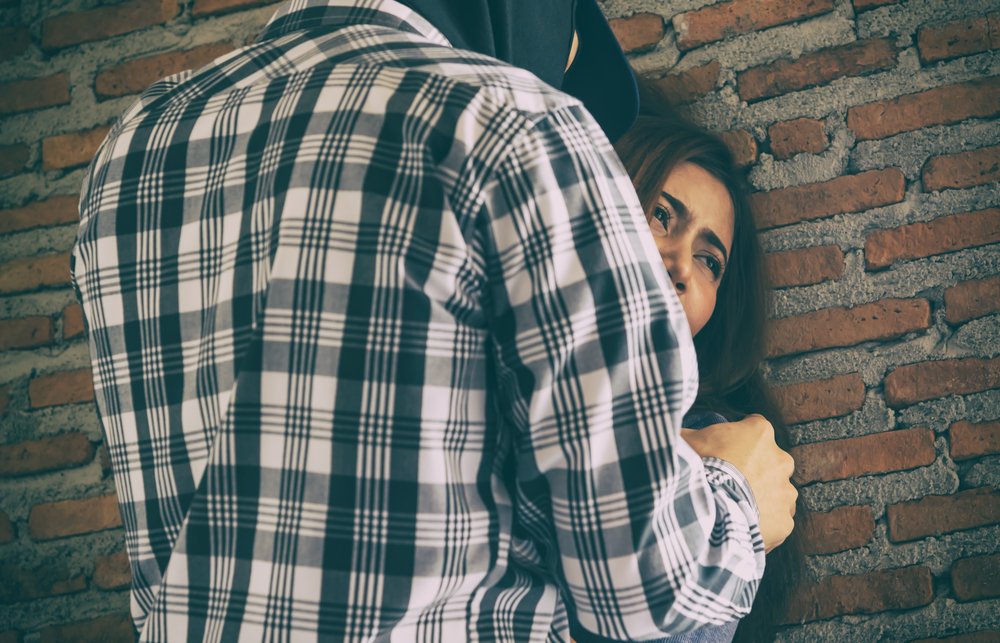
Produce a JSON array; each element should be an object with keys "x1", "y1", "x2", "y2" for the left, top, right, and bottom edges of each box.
[{"x1": 257, "y1": 0, "x2": 452, "y2": 47}]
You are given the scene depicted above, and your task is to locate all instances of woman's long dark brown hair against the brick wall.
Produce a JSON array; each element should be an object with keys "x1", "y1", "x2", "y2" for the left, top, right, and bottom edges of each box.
[{"x1": 615, "y1": 86, "x2": 802, "y2": 643}]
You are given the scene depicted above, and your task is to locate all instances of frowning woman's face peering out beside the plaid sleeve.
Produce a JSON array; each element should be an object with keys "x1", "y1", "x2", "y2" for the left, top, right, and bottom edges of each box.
[{"x1": 649, "y1": 162, "x2": 735, "y2": 336}]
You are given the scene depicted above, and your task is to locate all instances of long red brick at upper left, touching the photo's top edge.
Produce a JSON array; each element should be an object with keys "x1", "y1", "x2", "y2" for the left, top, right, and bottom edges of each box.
[{"x1": 42, "y1": 0, "x2": 178, "y2": 49}]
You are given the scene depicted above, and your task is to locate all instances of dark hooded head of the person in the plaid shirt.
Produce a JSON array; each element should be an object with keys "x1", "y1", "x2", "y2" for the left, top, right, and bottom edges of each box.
[{"x1": 398, "y1": 0, "x2": 639, "y2": 142}]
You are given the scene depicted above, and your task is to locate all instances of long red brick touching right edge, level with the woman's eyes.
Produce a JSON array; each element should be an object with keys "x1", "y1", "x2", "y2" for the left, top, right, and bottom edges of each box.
[{"x1": 865, "y1": 208, "x2": 1000, "y2": 269}]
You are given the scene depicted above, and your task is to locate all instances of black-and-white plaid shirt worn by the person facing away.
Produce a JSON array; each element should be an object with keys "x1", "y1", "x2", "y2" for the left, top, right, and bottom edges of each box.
[{"x1": 73, "y1": 0, "x2": 763, "y2": 641}]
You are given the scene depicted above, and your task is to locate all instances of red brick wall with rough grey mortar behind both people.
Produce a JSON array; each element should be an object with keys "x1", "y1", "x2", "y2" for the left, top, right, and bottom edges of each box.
[{"x1": 0, "y1": 0, "x2": 1000, "y2": 643}]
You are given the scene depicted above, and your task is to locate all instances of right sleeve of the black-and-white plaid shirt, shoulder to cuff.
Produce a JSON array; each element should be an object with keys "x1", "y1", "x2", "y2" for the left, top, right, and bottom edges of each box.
[{"x1": 483, "y1": 105, "x2": 764, "y2": 640}]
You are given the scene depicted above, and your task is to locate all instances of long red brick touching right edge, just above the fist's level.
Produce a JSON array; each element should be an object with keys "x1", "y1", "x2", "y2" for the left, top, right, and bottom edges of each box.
[{"x1": 883, "y1": 358, "x2": 1000, "y2": 407}]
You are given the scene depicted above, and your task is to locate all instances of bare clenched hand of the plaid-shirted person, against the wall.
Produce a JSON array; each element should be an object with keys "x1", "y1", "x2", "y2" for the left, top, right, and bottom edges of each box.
[{"x1": 681, "y1": 415, "x2": 799, "y2": 551}]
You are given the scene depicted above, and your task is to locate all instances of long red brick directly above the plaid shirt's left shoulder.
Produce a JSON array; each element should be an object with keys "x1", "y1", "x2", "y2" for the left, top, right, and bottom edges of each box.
[{"x1": 94, "y1": 43, "x2": 233, "y2": 98}]
